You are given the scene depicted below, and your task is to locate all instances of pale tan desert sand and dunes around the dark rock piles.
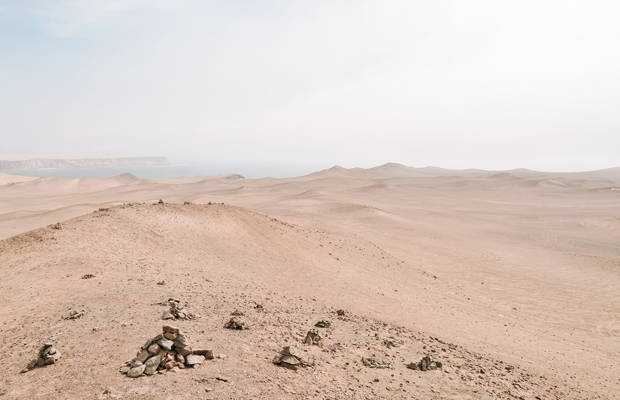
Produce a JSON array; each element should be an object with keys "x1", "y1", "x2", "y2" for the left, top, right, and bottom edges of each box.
[{"x1": 0, "y1": 164, "x2": 620, "y2": 400}]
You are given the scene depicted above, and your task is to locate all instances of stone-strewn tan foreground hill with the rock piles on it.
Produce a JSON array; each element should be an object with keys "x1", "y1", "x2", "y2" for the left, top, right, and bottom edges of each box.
[{"x1": 0, "y1": 204, "x2": 593, "y2": 400}]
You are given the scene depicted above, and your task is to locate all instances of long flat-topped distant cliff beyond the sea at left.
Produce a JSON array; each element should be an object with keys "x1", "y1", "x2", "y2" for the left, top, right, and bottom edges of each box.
[{"x1": 0, "y1": 156, "x2": 170, "y2": 170}]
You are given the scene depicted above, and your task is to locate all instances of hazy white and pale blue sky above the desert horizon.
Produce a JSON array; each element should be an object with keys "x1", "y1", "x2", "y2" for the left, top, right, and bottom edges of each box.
[{"x1": 0, "y1": 0, "x2": 620, "y2": 172}]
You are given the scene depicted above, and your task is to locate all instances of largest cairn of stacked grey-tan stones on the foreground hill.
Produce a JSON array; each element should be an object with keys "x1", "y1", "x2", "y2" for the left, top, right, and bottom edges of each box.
[{"x1": 120, "y1": 325, "x2": 213, "y2": 378}]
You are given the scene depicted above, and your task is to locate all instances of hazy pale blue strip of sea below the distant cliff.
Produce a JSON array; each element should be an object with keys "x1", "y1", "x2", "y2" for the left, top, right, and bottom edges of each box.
[{"x1": 0, "y1": 164, "x2": 317, "y2": 179}]
